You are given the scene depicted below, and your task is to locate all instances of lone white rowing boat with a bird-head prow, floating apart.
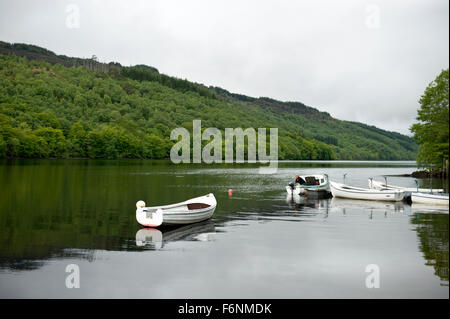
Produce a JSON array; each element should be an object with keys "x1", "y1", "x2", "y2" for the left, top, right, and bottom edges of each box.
[{"x1": 136, "y1": 193, "x2": 217, "y2": 227}]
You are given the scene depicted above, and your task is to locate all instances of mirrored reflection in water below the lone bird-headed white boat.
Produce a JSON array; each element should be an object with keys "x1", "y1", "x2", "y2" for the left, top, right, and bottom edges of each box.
[{"x1": 136, "y1": 220, "x2": 216, "y2": 250}]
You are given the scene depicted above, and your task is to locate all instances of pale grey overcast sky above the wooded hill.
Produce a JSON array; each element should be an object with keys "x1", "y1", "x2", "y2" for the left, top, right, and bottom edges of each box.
[{"x1": 0, "y1": 0, "x2": 449, "y2": 134}]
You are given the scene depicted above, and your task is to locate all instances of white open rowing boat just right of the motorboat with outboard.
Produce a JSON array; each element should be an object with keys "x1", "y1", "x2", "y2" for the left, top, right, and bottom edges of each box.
[{"x1": 330, "y1": 182, "x2": 405, "y2": 202}]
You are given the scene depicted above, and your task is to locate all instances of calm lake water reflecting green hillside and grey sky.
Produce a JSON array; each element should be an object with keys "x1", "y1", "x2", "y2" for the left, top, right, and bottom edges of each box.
[{"x1": 0, "y1": 160, "x2": 449, "y2": 298}]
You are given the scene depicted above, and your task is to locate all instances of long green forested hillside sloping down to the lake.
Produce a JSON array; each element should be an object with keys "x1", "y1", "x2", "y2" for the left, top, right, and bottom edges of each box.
[{"x1": 0, "y1": 42, "x2": 417, "y2": 160}]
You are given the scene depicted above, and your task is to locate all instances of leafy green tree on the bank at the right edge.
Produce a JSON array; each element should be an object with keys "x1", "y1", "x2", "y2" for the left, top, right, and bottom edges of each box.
[{"x1": 410, "y1": 69, "x2": 449, "y2": 168}]
